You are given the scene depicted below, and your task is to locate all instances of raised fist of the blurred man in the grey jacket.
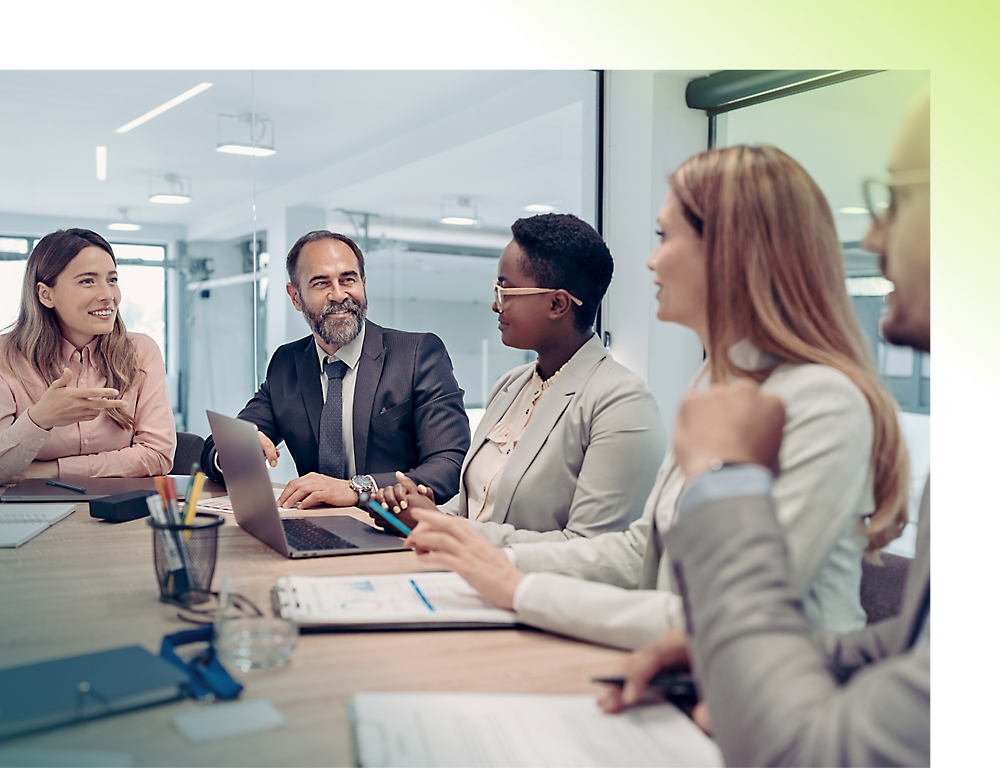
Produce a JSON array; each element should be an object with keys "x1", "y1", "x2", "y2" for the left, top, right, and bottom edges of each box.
[{"x1": 674, "y1": 379, "x2": 785, "y2": 477}]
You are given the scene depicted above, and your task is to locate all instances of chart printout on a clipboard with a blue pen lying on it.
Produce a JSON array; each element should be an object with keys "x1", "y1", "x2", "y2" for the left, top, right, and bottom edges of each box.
[{"x1": 273, "y1": 573, "x2": 517, "y2": 630}]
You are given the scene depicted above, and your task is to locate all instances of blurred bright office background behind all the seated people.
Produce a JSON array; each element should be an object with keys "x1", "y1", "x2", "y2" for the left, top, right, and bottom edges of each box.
[{"x1": 0, "y1": 70, "x2": 930, "y2": 552}]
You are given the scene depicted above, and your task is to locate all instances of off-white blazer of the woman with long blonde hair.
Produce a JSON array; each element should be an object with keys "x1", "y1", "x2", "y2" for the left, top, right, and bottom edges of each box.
[{"x1": 512, "y1": 365, "x2": 874, "y2": 648}]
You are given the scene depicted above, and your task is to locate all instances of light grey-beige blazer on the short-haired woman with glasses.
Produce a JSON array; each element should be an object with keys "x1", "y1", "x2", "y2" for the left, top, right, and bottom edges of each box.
[{"x1": 441, "y1": 336, "x2": 667, "y2": 545}]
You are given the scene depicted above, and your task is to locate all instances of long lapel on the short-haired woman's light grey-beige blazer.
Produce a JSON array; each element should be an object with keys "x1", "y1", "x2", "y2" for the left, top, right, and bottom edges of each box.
[{"x1": 490, "y1": 336, "x2": 607, "y2": 523}]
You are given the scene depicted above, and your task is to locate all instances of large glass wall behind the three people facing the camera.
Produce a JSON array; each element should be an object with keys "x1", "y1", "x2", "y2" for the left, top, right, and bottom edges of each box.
[{"x1": 0, "y1": 70, "x2": 598, "y2": 479}]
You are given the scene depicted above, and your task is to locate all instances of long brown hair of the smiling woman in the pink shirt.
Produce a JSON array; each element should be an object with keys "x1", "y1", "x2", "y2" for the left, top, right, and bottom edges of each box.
[{"x1": 0, "y1": 229, "x2": 140, "y2": 429}]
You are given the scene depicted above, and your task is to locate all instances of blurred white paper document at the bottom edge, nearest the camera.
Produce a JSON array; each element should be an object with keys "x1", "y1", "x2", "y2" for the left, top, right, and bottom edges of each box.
[{"x1": 348, "y1": 693, "x2": 723, "y2": 768}]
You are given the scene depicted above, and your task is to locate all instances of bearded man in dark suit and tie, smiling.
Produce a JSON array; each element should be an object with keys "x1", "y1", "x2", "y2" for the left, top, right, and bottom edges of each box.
[{"x1": 202, "y1": 230, "x2": 469, "y2": 507}]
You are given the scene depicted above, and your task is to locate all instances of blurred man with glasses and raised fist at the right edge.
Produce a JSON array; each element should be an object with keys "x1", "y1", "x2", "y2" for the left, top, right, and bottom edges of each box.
[{"x1": 601, "y1": 87, "x2": 931, "y2": 768}]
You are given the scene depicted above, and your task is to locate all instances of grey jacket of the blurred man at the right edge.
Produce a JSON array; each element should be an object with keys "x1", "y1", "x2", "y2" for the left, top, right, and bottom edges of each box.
[{"x1": 667, "y1": 478, "x2": 932, "y2": 768}]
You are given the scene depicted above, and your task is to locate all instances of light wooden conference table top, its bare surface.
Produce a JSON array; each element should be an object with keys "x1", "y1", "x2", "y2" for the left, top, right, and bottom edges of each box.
[{"x1": 0, "y1": 489, "x2": 625, "y2": 768}]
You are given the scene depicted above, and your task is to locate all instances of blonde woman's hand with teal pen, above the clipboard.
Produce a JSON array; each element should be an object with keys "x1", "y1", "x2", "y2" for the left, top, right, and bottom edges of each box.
[{"x1": 405, "y1": 509, "x2": 524, "y2": 610}]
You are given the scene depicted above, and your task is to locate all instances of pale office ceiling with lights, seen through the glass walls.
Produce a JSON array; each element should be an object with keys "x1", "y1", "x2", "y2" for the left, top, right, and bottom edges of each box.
[{"x1": 0, "y1": 70, "x2": 926, "y2": 249}]
